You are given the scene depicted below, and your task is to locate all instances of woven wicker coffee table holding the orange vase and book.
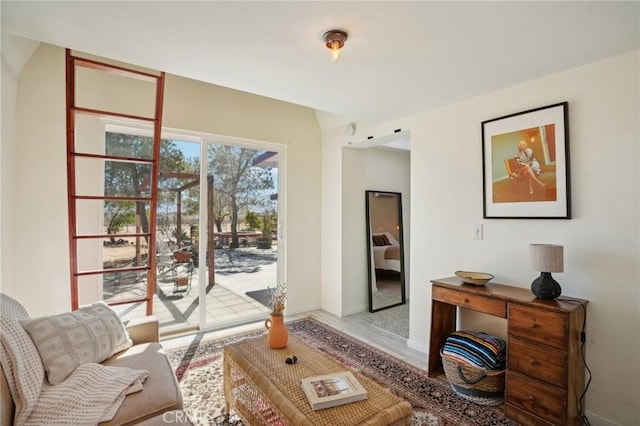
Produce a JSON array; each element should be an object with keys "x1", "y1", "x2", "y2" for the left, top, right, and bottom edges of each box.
[{"x1": 224, "y1": 334, "x2": 412, "y2": 426}]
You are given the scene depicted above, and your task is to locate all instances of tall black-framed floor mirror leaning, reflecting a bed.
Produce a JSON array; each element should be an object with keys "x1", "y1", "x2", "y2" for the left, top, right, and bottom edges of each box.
[{"x1": 365, "y1": 191, "x2": 406, "y2": 312}]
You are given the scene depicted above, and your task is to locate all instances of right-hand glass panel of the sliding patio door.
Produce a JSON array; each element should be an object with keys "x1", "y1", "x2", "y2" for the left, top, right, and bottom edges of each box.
[{"x1": 199, "y1": 143, "x2": 278, "y2": 328}]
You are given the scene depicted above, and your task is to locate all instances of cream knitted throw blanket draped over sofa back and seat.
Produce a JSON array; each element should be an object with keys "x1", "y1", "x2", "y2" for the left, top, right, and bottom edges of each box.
[{"x1": 0, "y1": 294, "x2": 149, "y2": 426}]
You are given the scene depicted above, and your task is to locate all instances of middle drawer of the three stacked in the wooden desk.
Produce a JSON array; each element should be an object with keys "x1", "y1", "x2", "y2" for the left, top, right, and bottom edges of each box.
[{"x1": 507, "y1": 337, "x2": 567, "y2": 388}]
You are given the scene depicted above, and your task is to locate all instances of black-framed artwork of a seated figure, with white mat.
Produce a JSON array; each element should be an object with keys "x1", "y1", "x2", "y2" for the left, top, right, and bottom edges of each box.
[{"x1": 482, "y1": 102, "x2": 571, "y2": 219}]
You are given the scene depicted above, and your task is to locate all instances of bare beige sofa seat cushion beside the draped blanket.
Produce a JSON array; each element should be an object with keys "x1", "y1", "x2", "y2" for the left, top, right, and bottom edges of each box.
[{"x1": 100, "y1": 343, "x2": 182, "y2": 426}]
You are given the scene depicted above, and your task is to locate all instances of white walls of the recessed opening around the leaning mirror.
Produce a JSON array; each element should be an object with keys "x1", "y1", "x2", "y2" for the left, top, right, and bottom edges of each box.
[{"x1": 342, "y1": 148, "x2": 411, "y2": 315}]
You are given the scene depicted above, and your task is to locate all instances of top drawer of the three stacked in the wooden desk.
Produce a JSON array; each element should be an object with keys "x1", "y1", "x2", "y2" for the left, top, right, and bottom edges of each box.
[{"x1": 508, "y1": 303, "x2": 569, "y2": 349}]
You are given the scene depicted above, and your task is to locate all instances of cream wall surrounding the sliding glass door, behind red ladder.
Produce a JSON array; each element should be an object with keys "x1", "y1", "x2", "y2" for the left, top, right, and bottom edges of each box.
[{"x1": 2, "y1": 45, "x2": 321, "y2": 316}]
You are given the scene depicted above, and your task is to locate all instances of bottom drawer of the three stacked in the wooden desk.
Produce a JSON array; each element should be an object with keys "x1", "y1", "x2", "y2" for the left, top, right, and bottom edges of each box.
[{"x1": 505, "y1": 370, "x2": 567, "y2": 425}]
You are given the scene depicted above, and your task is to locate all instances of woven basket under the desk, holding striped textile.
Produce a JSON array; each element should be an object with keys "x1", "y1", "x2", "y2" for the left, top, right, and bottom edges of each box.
[{"x1": 440, "y1": 349, "x2": 505, "y2": 405}]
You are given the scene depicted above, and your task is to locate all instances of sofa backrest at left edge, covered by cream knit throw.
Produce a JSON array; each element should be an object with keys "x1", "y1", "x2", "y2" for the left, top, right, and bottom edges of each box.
[{"x1": 0, "y1": 294, "x2": 44, "y2": 424}]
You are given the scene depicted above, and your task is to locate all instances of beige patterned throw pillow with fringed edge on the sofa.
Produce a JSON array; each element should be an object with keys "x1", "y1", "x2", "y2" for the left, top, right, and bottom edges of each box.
[{"x1": 20, "y1": 302, "x2": 133, "y2": 385}]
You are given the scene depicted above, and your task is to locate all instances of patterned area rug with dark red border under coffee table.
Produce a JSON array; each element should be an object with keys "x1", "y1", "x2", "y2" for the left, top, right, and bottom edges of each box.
[{"x1": 167, "y1": 318, "x2": 518, "y2": 426}]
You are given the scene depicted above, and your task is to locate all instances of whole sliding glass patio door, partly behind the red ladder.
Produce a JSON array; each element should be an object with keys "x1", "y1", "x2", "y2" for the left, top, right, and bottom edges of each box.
[{"x1": 104, "y1": 126, "x2": 284, "y2": 334}]
